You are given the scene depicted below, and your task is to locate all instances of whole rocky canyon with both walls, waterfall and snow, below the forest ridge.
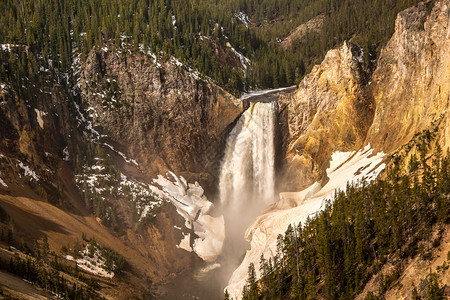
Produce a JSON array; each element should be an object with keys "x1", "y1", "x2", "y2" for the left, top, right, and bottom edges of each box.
[{"x1": 0, "y1": 0, "x2": 450, "y2": 299}]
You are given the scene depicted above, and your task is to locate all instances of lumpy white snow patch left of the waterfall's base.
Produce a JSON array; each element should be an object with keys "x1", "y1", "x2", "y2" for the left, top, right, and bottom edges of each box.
[{"x1": 151, "y1": 172, "x2": 225, "y2": 261}]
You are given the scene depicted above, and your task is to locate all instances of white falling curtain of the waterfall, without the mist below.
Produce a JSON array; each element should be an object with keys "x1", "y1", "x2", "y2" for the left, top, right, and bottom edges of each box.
[{"x1": 219, "y1": 102, "x2": 276, "y2": 212}]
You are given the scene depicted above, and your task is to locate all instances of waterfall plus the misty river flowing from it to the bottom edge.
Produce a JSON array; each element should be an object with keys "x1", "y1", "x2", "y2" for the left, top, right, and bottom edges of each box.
[{"x1": 162, "y1": 94, "x2": 286, "y2": 299}]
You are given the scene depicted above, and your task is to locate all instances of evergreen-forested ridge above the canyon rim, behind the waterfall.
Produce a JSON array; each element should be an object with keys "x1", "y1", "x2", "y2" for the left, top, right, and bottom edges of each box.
[{"x1": 0, "y1": 0, "x2": 418, "y2": 94}]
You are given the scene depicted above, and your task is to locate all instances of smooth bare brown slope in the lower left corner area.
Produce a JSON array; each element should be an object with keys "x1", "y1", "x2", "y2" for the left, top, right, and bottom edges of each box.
[{"x1": 0, "y1": 195, "x2": 158, "y2": 299}]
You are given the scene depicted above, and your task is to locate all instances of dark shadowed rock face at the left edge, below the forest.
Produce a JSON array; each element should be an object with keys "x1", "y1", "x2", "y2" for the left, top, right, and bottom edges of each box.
[{"x1": 0, "y1": 84, "x2": 77, "y2": 206}]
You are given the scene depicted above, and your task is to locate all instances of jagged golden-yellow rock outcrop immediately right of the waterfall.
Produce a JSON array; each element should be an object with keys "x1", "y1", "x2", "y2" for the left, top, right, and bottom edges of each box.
[{"x1": 279, "y1": 42, "x2": 373, "y2": 191}]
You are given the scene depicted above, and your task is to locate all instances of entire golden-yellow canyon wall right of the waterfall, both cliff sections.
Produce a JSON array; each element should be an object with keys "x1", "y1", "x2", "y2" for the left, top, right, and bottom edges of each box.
[{"x1": 279, "y1": 0, "x2": 450, "y2": 190}]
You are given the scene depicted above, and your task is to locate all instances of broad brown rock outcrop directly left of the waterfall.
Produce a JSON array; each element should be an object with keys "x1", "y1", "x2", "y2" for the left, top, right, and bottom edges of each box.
[{"x1": 80, "y1": 50, "x2": 243, "y2": 192}]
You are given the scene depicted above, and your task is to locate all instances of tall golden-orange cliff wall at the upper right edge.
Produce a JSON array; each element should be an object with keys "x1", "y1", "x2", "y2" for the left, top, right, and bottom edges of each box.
[{"x1": 367, "y1": 0, "x2": 450, "y2": 152}]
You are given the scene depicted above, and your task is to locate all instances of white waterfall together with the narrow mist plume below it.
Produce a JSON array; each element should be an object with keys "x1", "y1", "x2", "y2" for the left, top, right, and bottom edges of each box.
[{"x1": 219, "y1": 102, "x2": 277, "y2": 280}]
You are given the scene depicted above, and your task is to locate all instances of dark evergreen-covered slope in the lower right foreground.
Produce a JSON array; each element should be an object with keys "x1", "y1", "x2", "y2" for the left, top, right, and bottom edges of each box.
[{"x1": 237, "y1": 137, "x2": 450, "y2": 299}]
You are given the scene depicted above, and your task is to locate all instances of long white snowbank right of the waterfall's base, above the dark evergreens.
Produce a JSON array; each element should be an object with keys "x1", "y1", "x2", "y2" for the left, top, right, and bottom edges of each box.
[{"x1": 226, "y1": 145, "x2": 385, "y2": 299}]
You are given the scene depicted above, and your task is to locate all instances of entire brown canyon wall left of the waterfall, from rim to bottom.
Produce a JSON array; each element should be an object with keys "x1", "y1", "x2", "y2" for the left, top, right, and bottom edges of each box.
[{"x1": 0, "y1": 43, "x2": 243, "y2": 299}]
